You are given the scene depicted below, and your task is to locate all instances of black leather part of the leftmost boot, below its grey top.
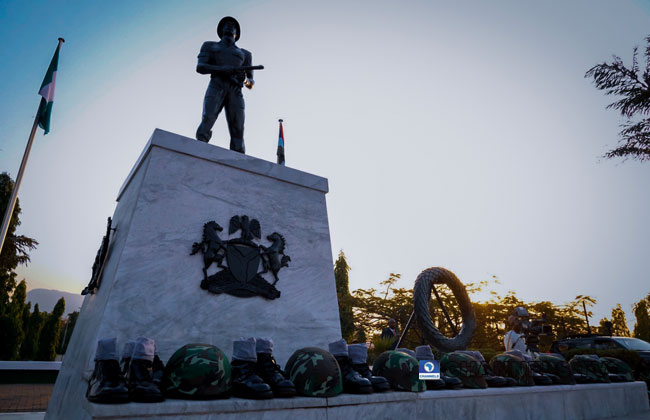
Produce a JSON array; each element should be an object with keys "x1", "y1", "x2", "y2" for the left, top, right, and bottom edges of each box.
[{"x1": 86, "y1": 360, "x2": 129, "y2": 404}]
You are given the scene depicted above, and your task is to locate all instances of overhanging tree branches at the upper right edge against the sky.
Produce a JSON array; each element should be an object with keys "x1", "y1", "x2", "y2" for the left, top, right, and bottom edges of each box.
[{"x1": 585, "y1": 36, "x2": 650, "y2": 161}]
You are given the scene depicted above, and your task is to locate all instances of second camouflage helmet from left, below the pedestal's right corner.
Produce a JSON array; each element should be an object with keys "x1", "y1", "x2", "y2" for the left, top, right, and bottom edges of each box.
[{"x1": 284, "y1": 347, "x2": 343, "y2": 397}]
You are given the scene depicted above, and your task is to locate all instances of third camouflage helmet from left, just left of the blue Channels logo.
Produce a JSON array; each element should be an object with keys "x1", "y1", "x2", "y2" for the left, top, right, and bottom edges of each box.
[{"x1": 372, "y1": 350, "x2": 427, "y2": 392}]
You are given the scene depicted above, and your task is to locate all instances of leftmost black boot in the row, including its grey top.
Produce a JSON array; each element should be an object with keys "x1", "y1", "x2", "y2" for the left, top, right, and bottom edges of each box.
[{"x1": 86, "y1": 338, "x2": 129, "y2": 404}]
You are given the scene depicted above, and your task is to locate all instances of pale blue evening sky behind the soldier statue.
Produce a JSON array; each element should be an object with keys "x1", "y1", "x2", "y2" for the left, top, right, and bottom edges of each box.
[{"x1": 0, "y1": 0, "x2": 650, "y2": 328}]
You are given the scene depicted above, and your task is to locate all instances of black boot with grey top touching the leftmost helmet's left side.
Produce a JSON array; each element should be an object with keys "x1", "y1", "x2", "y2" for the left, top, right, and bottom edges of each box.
[{"x1": 126, "y1": 337, "x2": 165, "y2": 402}]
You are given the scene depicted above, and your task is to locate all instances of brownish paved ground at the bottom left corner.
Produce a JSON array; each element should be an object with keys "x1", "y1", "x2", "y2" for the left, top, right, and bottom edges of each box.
[{"x1": 0, "y1": 384, "x2": 54, "y2": 413}]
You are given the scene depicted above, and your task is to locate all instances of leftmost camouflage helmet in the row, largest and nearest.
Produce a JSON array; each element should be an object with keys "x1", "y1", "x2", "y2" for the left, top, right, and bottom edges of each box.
[{"x1": 161, "y1": 344, "x2": 230, "y2": 399}]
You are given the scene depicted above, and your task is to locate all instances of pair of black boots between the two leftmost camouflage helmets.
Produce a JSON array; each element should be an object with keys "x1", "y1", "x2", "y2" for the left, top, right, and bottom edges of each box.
[{"x1": 230, "y1": 353, "x2": 296, "y2": 400}]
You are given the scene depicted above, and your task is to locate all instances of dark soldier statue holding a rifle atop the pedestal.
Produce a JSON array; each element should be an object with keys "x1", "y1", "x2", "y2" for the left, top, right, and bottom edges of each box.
[{"x1": 196, "y1": 16, "x2": 264, "y2": 153}]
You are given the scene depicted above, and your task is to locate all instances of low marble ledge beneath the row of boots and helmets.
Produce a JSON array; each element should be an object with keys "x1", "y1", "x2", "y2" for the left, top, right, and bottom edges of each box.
[{"x1": 79, "y1": 382, "x2": 650, "y2": 420}]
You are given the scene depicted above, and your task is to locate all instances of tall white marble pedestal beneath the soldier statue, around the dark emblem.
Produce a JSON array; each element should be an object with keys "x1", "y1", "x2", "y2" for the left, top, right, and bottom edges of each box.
[{"x1": 46, "y1": 129, "x2": 341, "y2": 419}]
